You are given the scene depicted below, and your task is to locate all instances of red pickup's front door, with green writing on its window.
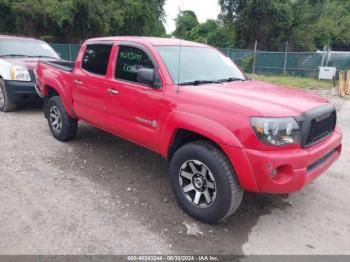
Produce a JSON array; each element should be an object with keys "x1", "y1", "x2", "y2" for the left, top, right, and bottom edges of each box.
[{"x1": 107, "y1": 44, "x2": 164, "y2": 150}]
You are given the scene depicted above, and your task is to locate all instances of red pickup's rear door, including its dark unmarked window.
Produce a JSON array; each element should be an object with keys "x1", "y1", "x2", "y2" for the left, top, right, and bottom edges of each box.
[{"x1": 72, "y1": 43, "x2": 113, "y2": 129}]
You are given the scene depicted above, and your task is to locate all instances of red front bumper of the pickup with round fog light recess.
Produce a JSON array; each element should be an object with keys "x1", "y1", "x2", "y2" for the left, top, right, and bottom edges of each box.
[{"x1": 226, "y1": 129, "x2": 342, "y2": 193}]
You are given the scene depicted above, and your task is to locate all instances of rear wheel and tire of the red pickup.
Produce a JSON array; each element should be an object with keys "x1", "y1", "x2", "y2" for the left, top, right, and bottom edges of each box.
[{"x1": 47, "y1": 96, "x2": 78, "y2": 142}]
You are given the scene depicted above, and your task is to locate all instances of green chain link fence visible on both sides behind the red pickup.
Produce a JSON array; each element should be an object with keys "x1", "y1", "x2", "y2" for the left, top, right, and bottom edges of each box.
[{"x1": 51, "y1": 44, "x2": 350, "y2": 78}]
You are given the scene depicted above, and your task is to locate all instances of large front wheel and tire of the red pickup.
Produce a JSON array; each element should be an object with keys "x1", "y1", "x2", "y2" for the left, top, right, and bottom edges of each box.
[{"x1": 170, "y1": 141, "x2": 244, "y2": 223}]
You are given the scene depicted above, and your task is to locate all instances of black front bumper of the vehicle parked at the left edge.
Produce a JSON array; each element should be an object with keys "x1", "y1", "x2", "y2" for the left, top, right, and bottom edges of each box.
[{"x1": 5, "y1": 80, "x2": 42, "y2": 104}]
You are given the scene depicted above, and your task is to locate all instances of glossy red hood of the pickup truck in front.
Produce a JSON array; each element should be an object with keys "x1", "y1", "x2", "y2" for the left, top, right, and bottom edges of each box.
[{"x1": 188, "y1": 80, "x2": 329, "y2": 117}]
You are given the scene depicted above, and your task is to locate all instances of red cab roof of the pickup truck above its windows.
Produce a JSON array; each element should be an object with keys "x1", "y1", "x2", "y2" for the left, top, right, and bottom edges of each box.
[{"x1": 86, "y1": 36, "x2": 208, "y2": 47}]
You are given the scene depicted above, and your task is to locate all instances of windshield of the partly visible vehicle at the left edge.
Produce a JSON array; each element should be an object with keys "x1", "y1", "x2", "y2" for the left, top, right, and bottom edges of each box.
[{"x1": 0, "y1": 39, "x2": 59, "y2": 59}]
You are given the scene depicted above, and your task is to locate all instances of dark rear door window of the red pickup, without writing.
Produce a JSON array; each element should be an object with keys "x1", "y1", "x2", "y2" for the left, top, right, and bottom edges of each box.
[{"x1": 82, "y1": 44, "x2": 112, "y2": 76}]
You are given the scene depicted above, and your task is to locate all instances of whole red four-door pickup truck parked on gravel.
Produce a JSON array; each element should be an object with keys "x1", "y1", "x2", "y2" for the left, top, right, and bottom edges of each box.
[{"x1": 37, "y1": 37, "x2": 342, "y2": 223}]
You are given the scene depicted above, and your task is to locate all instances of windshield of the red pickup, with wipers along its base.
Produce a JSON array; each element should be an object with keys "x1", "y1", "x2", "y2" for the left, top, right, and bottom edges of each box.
[{"x1": 157, "y1": 46, "x2": 245, "y2": 84}]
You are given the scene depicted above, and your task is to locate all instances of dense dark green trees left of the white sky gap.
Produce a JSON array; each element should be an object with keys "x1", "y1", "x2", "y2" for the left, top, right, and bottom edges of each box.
[{"x1": 0, "y1": 0, "x2": 165, "y2": 42}]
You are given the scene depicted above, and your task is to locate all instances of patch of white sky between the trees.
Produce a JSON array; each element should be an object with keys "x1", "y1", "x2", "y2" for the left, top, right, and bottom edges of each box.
[{"x1": 165, "y1": 0, "x2": 220, "y2": 33}]
